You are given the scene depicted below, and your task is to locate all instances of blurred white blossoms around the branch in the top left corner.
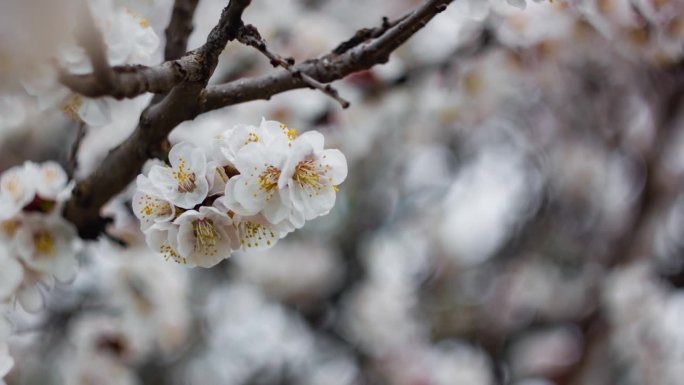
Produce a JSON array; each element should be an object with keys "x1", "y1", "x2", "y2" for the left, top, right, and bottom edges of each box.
[{"x1": 22, "y1": 0, "x2": 159, "y2": 126}]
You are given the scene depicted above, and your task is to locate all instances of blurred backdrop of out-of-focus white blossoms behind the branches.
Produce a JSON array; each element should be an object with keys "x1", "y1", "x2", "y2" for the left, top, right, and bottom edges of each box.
[{"x1": 0, "y1": 0, "x2": 684, "y2": 385}]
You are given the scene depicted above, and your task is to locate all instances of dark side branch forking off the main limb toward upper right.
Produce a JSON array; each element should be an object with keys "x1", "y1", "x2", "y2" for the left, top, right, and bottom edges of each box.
[{"x1": 203, "y1": 0, "x2": 453, "y2": 111}]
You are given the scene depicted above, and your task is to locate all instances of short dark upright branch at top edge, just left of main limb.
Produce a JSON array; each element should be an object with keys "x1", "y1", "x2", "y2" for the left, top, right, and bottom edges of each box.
[{"x1": 164, "y1": 0, "x2": 199, "y2": 61}]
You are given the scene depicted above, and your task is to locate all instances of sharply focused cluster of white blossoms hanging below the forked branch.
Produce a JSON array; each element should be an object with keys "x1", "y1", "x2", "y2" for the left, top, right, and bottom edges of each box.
[{"x1": 133, "y1": 120, "x2": 347, "y2": 267}]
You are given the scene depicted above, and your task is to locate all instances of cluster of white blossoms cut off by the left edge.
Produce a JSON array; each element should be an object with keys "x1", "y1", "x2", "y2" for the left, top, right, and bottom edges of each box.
[{"x1": 0, "y1": 162, "x2": 79, "y2": 383}]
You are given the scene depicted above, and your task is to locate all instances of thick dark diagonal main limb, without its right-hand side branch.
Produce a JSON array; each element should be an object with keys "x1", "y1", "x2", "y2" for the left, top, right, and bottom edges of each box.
[{"x1": 63, "y1": 0, "x2": 251, "y2": 239}]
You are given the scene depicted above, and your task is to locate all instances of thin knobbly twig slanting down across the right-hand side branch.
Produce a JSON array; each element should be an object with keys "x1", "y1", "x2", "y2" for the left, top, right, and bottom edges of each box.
[{"x1": 238, "y1": 25, "x2": 349, "y2": 108}]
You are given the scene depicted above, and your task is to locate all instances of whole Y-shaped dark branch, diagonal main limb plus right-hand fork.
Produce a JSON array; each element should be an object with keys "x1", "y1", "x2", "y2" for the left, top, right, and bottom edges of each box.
[{"x1": 64, "y1": 0, "x2": 453, "y2": 239}]
